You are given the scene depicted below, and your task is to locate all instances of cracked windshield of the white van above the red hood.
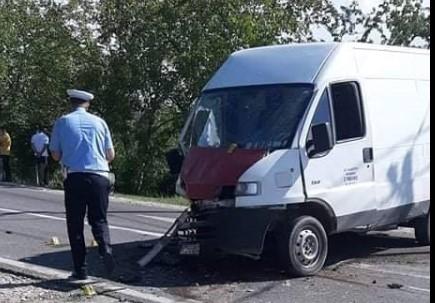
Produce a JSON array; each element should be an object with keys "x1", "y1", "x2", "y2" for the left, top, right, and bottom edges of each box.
[{"x1": 186, "y1": 84, "x2": 313, "y2": 150}]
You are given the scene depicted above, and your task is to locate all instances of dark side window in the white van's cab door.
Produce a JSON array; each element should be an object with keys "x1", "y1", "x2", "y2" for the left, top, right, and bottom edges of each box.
[{"x1": 331, "y1": 82, "x2": 365, "y2": 142}]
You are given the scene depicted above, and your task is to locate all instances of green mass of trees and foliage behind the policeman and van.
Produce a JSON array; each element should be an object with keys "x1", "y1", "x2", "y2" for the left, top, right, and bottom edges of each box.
[{"x1": 0, "y1": 0, "x2": 430, "y2": 195}]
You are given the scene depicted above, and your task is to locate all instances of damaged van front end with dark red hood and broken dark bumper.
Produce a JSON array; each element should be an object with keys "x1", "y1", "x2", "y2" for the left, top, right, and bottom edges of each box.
[{"x1": 179, "y1": 149, "x2": 304, "y2": 258}]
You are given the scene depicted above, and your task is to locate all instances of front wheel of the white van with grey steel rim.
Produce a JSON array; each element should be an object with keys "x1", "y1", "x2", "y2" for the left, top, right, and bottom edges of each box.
[{"x1": 278, "y1": 216, "x2": 328, "y2": 276}]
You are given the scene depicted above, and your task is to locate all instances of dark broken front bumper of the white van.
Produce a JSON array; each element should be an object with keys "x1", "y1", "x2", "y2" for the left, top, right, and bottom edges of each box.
[{"x1": 179, "y1": 208, "x2": 284, "y2": 258}]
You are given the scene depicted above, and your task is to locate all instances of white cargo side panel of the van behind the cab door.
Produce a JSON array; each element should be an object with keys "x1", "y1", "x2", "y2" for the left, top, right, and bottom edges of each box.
[{"x1": 355, "y1": 48, "x2": 430, "y2": 216}]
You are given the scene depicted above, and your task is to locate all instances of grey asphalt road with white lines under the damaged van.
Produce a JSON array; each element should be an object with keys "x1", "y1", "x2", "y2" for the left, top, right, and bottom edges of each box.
[{"x1": 0, "y1": 185, "x2": 430, "y2": 303}]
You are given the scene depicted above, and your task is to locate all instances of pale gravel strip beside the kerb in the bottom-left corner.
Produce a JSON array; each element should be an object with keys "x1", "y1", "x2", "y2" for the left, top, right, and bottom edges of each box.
[{"x1": 0, "y1": 271, "x2": 128, "y2": 303}]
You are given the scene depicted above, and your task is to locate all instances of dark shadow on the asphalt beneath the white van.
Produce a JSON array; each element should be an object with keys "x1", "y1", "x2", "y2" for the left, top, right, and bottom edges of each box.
[{"x1": 24, "y1": 233, "x2": 428, "y2": 288}]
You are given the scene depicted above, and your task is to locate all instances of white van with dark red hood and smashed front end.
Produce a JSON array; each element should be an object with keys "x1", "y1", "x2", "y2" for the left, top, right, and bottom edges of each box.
[{"x1": 171, "y1": 43, "x2": 430, "y2": 276}]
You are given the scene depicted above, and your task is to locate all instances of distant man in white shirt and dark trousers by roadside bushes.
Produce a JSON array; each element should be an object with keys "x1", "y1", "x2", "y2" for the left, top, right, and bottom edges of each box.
[{"x1": 31, "y1": 127, "x2": 50, "y2": 186}]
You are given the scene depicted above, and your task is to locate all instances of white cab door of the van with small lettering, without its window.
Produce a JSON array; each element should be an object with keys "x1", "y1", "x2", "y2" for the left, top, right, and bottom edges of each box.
[{"x1": 299, "y1": 44, "x2": 377, "y2": 226}]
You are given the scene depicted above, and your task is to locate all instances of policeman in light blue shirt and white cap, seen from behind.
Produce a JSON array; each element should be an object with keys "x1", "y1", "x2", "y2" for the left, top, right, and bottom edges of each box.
[{"x1": 50, "y1": 90, "x2": 115, "y2": 280}]
